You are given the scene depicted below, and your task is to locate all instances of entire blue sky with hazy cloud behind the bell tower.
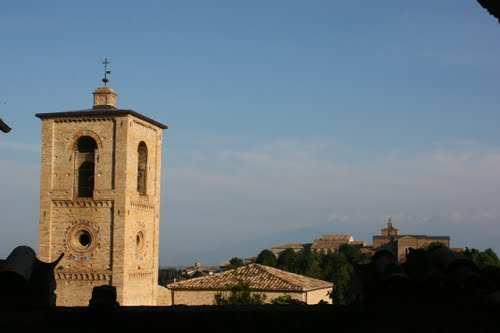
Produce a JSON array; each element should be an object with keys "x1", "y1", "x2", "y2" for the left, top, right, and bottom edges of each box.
[{"x1": 0, "y1": 0, "x2": 500, "y2": 265}]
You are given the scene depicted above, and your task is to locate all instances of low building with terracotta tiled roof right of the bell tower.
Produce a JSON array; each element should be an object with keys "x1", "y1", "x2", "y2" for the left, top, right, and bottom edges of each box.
[{"x1": 167, "y1": 264, "x2": 333, "y2": 305}]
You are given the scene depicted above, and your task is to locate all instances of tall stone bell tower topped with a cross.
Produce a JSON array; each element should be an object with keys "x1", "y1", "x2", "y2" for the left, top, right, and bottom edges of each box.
[{"x1": 36, "y1": 76, "x2": 167, "y2": 306}]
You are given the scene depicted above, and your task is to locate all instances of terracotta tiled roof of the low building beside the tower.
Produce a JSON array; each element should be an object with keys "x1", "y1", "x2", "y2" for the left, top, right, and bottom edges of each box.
[{"x1": 167, "y1": 264, "x2": 333, "y2": 292}]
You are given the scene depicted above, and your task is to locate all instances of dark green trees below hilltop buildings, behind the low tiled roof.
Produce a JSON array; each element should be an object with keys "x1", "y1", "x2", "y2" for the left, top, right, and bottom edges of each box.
[{"x1": 250, "y1": 244, "x2": 500, "y2": 305}]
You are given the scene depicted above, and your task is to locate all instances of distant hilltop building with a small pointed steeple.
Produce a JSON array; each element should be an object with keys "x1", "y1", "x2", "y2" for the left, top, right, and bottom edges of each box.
[{"x1": 373, "y1": 218, "x2": 450, "y2": 261}]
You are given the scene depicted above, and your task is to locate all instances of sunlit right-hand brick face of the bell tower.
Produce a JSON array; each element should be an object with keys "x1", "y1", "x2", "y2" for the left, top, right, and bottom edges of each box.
[{"x1": 123, "y1": 117, "x2": 162, "y2": 305}]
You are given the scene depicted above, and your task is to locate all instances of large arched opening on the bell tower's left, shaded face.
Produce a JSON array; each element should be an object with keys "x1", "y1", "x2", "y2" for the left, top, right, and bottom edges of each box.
[{"x1": 75, "y1": 136, "x2": 97, "y2": 198}]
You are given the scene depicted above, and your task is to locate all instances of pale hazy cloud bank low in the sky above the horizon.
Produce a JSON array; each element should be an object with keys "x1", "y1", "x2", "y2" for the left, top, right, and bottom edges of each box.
[{"x1": 0, "y1": 141, "x2": 500, "y2": 265}]
